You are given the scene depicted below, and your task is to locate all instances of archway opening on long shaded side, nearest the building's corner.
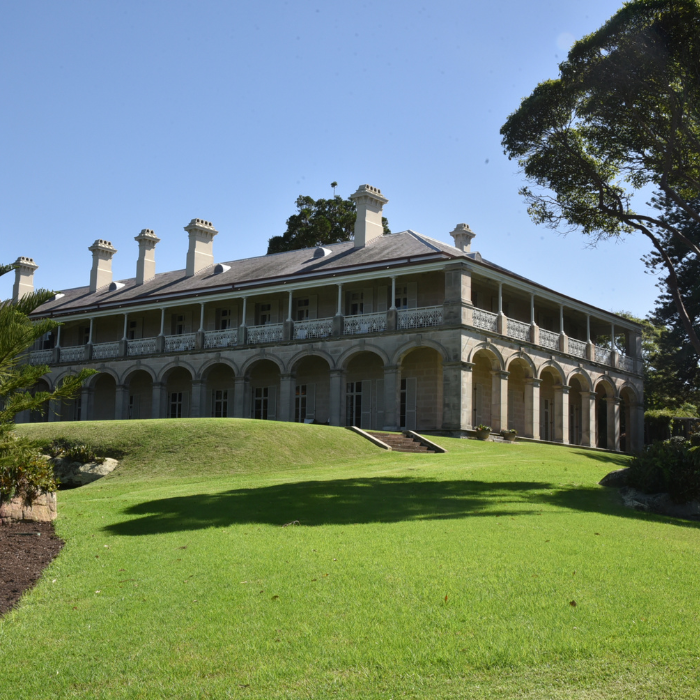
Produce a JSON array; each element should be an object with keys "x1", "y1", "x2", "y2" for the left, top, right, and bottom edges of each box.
[{"x1": 399, "y1": 348, "x2": 443, "y2": 430}]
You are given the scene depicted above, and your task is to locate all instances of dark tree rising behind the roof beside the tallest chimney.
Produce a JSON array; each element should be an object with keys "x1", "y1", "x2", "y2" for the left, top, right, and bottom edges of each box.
[{"x1": 267, "y1": 194, "x2": 391, "y2": 255}]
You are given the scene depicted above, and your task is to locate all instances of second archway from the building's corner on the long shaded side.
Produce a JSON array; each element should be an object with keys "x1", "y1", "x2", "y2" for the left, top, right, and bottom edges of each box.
[{"x1": 345, "y1": 351, "x2": 385, "y2": 430}]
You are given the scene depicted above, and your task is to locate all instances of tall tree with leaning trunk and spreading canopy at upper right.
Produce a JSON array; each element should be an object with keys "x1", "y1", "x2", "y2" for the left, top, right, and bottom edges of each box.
[{"x1": 501, "y1": 0, "x2": 700, "y2": 355}]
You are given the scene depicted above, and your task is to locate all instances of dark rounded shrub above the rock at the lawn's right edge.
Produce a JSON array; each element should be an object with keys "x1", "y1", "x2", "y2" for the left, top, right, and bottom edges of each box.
[{"x1": 629, "y1": 436, "x2": 700, "y2": 503}]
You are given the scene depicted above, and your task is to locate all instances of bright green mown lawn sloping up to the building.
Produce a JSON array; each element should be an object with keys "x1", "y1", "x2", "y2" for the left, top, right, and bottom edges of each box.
[{"x1": 5, "y1": 419, "x2": 700, "y2": 700}]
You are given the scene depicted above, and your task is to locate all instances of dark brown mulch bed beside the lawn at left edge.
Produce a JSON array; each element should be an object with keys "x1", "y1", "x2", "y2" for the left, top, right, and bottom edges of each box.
[{"x1": 0, "y1": 522, "x2": 64, "y2": 615}]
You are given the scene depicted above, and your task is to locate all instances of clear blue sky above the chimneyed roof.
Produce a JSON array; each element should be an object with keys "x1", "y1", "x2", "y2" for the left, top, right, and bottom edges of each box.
[{"x1": 0, "y1": 0, "x2": 657, "y2": 316}]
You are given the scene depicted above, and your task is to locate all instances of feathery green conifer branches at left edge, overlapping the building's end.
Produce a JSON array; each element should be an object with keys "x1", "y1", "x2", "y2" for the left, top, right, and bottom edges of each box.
[{"x1": 0, "y1": 265, "x2": 96, "y2": 500}]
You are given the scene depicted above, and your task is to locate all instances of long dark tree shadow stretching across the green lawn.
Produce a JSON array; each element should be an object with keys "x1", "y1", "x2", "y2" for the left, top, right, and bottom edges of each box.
[{"x1": 105, "y1": 477, "x2": 698, "y2": 535}]
